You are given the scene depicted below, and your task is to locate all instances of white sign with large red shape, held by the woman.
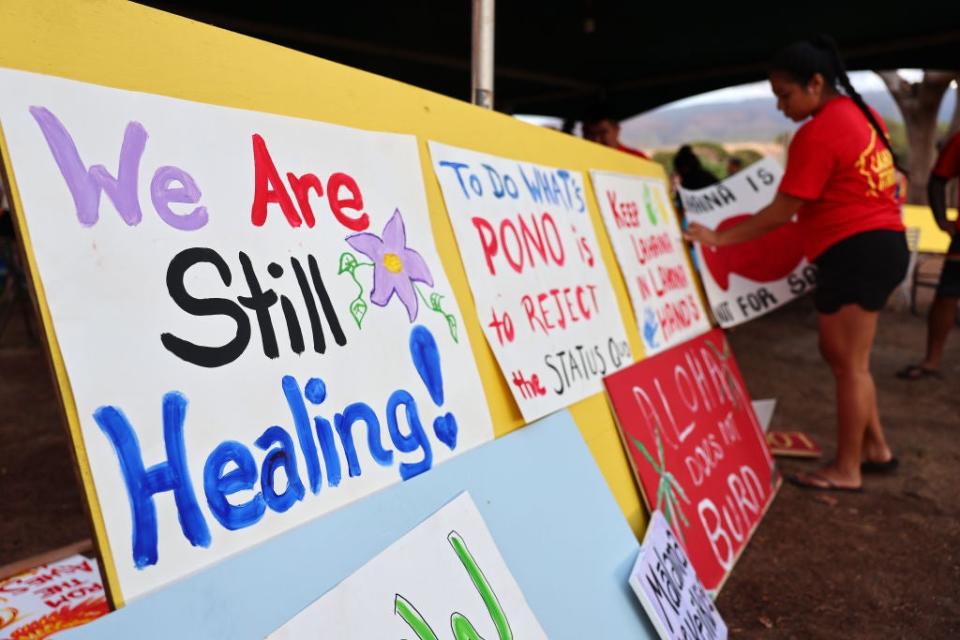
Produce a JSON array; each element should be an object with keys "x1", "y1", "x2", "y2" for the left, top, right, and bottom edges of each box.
[{"x1": 680, "y1": 158, "x2": 817, "y2": 327}]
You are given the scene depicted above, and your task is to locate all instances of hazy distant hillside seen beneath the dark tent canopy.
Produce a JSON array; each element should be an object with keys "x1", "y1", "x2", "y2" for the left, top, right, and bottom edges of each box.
[{"x1": 621, "y1": 91, "x2": 956, "y2": 149}]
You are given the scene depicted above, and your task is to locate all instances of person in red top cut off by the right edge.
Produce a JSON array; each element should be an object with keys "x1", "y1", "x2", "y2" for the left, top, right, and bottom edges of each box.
[{"x1": 897, "y1": 132, "x2": 960, "y2": 380}]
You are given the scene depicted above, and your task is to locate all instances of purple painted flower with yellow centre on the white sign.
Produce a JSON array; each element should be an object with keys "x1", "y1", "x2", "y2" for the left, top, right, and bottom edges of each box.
[{"x1": 347, "y1": 209, "x2": 433, "y2": 322}]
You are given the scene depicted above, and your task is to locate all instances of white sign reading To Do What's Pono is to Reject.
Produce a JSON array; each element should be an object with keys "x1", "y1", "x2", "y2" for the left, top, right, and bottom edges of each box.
[{"x1": 430, "y1": 142, "x2": 633, "y2": 421}]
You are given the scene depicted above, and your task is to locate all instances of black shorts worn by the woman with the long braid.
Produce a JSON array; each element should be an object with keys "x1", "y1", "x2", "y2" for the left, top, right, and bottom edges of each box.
[{"x1": 813, "y1": 229, "x2": 910, "y2": 313}]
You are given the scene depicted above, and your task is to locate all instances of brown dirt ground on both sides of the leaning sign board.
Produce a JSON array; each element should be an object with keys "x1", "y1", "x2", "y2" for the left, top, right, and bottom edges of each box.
[{"x1": 0, "y1": 272, "x2": 960, "y2": 639}]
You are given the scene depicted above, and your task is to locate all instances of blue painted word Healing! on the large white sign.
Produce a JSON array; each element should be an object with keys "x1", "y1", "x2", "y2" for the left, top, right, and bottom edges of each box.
[{"x1": 94, "y1": 325, "x2": 457, "y2": 569}]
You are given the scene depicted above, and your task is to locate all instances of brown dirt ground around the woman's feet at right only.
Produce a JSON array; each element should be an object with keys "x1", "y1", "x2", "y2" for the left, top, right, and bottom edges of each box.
[{"x1": 717, "y1": 292, "x2": 960, "y2": 638}]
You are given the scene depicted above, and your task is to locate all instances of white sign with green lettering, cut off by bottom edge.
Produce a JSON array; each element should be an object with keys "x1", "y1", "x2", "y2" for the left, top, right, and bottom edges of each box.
[{"x1": 269, "y1": 493, "x2": 547, "y2": 640}]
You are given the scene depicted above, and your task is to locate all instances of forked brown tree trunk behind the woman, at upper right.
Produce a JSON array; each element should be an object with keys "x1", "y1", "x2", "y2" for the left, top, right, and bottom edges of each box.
[{"x1": 877, "y1": 71, "x2": 960, "y2": 204}]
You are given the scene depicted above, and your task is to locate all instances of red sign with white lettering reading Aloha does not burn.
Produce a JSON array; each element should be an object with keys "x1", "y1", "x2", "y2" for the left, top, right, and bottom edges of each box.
[{"x1": 604, "y1": 329, "x2": 780, "y2": 591}]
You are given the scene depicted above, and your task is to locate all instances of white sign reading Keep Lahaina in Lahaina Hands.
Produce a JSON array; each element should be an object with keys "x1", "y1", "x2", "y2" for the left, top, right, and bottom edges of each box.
[{"x1": 590, "y1": 171, "x2": 710, "y2": 355}]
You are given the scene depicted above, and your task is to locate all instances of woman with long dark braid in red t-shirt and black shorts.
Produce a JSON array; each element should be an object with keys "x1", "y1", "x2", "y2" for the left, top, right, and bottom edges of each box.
[{"x1": 687, "y1": 36, "x2": 909, "y2": 491}]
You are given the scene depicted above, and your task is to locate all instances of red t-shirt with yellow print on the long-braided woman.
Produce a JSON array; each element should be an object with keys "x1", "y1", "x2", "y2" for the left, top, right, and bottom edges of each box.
[{"x1": 780, "y1": 96, "x2": 904, "y2": 260}]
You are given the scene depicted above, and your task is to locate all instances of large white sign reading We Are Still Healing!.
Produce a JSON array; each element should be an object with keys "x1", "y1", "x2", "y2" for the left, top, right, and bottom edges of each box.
[{"x1": 0, "y1": 70, "x2": 493, "y2": 600}]
